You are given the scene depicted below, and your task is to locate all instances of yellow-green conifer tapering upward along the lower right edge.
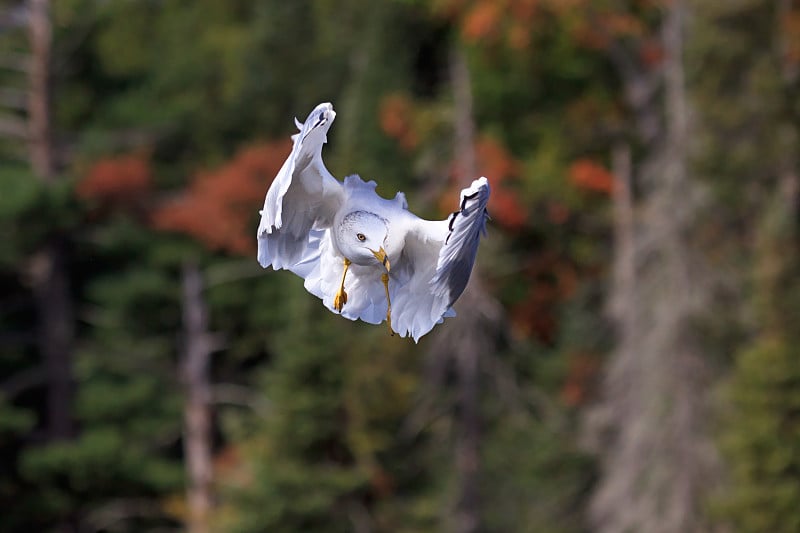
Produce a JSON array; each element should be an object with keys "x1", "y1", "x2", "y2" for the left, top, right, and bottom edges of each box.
[{"x1": 716, "y1": 159, "x2": 800, "y2": 532}]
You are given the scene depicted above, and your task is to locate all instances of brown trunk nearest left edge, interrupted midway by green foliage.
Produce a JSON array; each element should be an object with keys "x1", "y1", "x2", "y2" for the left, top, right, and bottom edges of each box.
[{"x1": 27, "y1": 0, "x2": 75, "y2": 440}]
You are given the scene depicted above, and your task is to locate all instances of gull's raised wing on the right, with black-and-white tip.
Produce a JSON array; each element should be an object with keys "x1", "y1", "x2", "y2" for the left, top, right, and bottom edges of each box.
[{"x1": 392, "y1": 177, "x2": 490, "y2": 341}]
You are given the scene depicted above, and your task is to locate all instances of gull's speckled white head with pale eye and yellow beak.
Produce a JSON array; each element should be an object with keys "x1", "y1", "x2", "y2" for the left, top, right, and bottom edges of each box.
[{"x1": 338, "y1": 211, "x2": 391, "y2": 271}]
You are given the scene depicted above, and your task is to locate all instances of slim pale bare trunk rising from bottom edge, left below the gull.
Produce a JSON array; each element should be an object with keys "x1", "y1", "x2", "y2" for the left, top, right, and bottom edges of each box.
[{"x1": 181, "y1": 263, "x2": 213, "y2": 533}]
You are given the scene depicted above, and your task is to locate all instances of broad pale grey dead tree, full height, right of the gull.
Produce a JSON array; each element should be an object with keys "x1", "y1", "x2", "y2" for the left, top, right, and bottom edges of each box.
[{"x1": 590, "y1": 0, "x2": 718, "y2": 533}]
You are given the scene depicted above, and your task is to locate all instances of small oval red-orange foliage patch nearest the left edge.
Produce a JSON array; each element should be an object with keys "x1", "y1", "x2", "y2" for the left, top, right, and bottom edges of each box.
[{"x1": 75, "y1": 155, "x2": 153, "y2": 204}]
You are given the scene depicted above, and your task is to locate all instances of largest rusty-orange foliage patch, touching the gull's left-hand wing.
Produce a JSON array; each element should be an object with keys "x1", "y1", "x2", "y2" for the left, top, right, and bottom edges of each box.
[{"x1": 152, "y1": 140, "x2": 291, "y2": 254}]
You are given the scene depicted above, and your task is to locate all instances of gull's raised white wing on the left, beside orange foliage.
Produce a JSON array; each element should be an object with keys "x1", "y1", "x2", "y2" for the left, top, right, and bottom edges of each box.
[{"x1": 258, "y1": 103, "x2": 344, "y2": 277}]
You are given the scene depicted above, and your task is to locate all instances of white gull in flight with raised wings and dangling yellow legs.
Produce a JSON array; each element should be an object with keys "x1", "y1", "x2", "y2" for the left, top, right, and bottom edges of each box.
[{"x1": 258, "y1": 103, "x2": 489, "y2": 342}]
